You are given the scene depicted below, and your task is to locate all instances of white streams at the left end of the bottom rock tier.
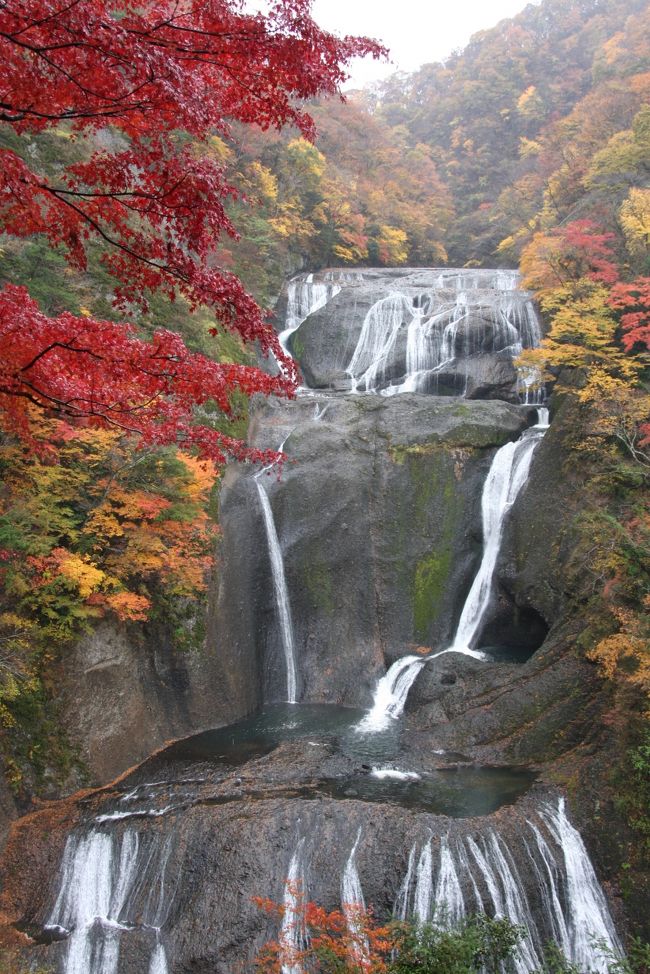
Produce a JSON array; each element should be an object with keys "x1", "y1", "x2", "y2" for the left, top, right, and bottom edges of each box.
[{"x1": 46, "y1": 831, "x2": 169, "y2": 974}]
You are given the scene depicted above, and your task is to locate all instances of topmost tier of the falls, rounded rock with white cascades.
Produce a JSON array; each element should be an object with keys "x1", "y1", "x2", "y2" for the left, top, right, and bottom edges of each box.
[{"x1": 281, "y1": 268, "x2": 541, "y2": 401}]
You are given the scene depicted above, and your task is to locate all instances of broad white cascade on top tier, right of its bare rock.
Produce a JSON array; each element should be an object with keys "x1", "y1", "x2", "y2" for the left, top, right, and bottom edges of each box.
[{"x1": 346, "y1": 271, "x2": 541, "y2": 394}]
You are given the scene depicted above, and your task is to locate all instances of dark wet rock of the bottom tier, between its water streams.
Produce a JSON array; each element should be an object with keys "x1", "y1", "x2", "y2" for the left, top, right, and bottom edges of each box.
[{"x1": 1, "y1": 728, "x2": 612, "y2": 974}]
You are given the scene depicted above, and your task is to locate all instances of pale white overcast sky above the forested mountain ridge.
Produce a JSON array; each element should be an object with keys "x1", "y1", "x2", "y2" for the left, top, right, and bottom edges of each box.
[{"x1": 313, "y1": 0, "x2": 538, "y2": 87}]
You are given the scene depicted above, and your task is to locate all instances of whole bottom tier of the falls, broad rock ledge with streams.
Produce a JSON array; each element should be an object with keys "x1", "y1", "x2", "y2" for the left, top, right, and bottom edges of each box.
[{"x1": 2, "y1": 707, "x2": 618, "y2": 974}]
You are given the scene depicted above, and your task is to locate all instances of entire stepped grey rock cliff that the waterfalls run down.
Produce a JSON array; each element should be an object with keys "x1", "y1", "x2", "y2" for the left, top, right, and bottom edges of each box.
[{"x1": 0, "y1": 270, "x2": 628, "y2": 974}]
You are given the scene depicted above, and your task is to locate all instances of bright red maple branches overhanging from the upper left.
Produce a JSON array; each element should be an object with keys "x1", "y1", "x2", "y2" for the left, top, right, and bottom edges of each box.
[{"x1": 0, "y1": 0, "x2": 382, "y2": 462}]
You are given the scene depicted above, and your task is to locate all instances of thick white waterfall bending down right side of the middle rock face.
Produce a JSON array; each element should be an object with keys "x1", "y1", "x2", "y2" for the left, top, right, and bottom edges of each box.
[{"x1": 357, "y1": 408, "x2": 548, "y2": 733}]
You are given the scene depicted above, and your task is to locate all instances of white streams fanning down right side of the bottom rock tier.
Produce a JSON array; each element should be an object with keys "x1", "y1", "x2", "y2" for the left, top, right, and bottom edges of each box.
[{"x1": 394, "y1": 798, "x2": 621, "y2": 974}]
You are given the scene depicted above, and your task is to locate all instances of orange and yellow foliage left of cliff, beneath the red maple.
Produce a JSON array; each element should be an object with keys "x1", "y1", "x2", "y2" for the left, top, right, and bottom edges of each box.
[{"x1": 0, "y1": 422, "x2": 217, "y2": 635}]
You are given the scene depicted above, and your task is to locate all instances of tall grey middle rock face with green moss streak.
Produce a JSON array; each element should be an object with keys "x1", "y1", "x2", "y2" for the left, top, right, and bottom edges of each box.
[{"x1": 213, "y1": 394, "x2": 527, "y2": 716}]
